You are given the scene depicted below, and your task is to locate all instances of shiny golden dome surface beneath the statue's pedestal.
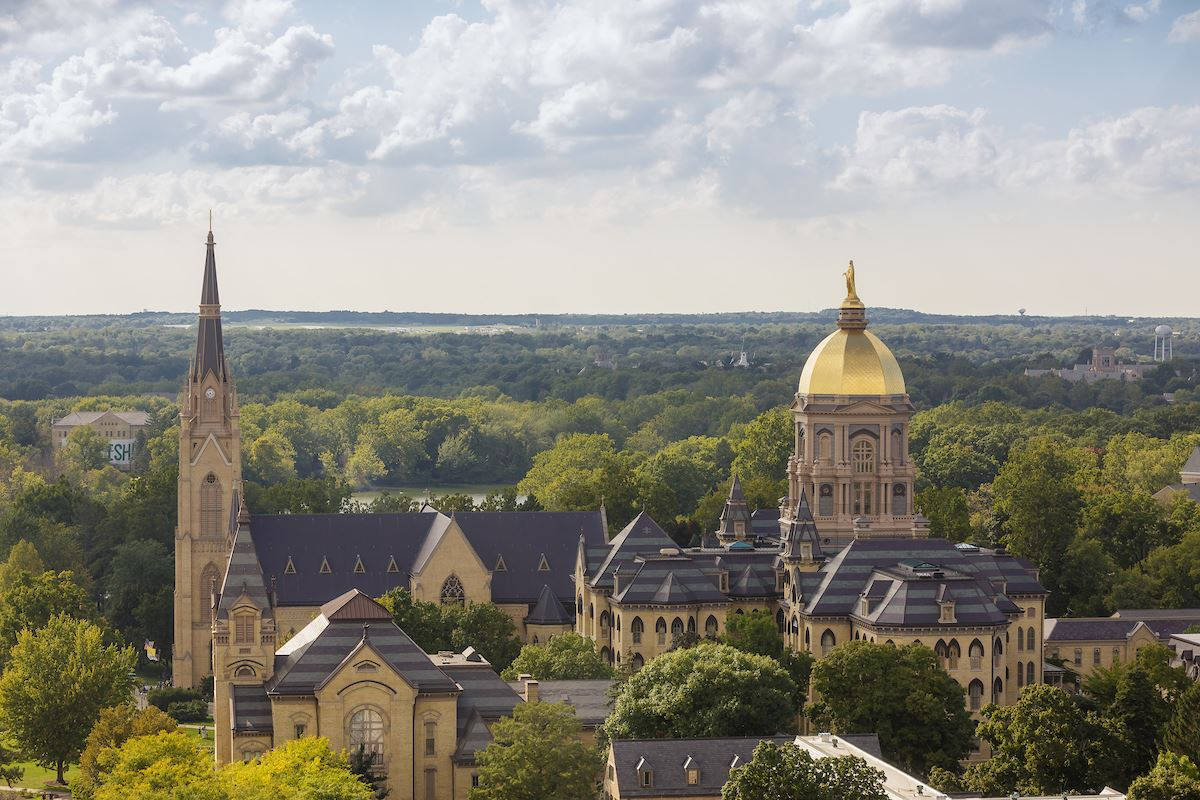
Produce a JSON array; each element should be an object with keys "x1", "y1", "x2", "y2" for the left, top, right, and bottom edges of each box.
[{"x1": 798, "y1": 327, "x2": 905, "y2": 395}]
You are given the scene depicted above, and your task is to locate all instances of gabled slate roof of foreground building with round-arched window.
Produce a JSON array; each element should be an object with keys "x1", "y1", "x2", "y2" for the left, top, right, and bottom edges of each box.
[{"x1": 266, "y1": 589, "x2": 458, "y2": 694}]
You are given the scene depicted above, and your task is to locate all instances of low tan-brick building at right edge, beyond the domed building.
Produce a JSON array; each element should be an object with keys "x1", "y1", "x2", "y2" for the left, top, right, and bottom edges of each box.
[{"x1": 1044, "y1": 608, "x2": 1200, "y2": 676}]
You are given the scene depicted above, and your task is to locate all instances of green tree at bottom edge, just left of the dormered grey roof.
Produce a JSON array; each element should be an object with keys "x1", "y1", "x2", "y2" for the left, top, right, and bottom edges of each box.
[{"x1": 469, "y1": 703, "x2": 604, "y2": 800}]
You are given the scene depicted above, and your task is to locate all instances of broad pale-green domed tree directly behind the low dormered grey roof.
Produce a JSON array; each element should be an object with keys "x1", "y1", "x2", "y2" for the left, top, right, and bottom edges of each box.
[{"x1": 605, "y1": 642, "x2": 796, "y2": 739}]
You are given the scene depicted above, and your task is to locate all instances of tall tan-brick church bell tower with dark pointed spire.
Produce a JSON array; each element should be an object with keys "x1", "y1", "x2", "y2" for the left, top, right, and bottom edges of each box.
[{"x1": 172, "y1": 219, "x2": 241, "y2": 686}]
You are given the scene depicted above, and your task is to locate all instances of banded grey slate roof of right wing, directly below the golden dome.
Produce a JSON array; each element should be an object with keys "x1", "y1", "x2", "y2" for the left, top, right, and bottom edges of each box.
[{"x1": 800, "y1": 539, "x2": 1045, "y2": 626}]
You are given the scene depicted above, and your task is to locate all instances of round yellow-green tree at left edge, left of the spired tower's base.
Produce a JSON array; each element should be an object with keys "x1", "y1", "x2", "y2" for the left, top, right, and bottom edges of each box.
[{"x1": 0, "y1": 614, "x2": 137, "y2": 783}]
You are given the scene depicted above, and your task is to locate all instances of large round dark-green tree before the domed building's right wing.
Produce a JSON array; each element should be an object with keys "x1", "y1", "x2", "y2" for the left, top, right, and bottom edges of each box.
[{"x1": 806, "y1": 640, "x2": 974, "y2": 775}]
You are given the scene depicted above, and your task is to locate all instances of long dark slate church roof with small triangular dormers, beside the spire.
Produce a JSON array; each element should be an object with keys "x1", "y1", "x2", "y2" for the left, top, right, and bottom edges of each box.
[{"x1": 244, "y1": 511, "x2": 604, "y2": 608}]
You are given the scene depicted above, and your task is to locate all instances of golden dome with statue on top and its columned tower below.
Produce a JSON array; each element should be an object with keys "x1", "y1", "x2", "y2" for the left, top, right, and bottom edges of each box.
[{"x1": 780, "y1": 261, "x2": 926, "y2": 551}]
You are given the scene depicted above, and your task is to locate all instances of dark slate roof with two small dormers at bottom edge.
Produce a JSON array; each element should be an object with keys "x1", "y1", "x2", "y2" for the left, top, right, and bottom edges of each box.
[{"x1": 612, "y1": 736, "x2": 794, "y2": 798}]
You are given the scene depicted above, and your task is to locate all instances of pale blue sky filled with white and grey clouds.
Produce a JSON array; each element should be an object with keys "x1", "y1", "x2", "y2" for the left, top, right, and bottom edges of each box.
[{"x1": 0, "y1": 0, "x2": 1200, "y2": 317}]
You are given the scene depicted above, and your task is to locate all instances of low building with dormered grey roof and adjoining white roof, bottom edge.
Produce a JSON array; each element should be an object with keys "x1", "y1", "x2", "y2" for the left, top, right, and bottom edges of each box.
[{"x1": 604, "y1": 733, "x2": 1126, "y2": 800}]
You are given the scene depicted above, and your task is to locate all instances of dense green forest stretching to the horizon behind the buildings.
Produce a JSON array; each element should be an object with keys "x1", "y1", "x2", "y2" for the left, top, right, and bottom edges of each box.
[{"x1": 0, "y1": 312, "x2": 1200, "y2": 662}]
